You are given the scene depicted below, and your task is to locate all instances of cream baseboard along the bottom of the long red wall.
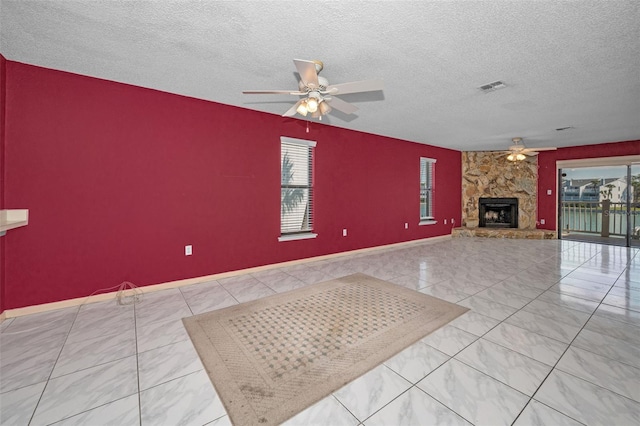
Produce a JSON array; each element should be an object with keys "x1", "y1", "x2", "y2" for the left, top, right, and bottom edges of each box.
[{"x1": 0, "y1": 234, "x2": 451, "y2": 321}]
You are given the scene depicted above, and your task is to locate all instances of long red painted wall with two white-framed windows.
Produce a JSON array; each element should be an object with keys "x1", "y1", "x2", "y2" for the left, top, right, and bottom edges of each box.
[{"x1": 3, "y1": 61, "x2": 462, "y2": 309}]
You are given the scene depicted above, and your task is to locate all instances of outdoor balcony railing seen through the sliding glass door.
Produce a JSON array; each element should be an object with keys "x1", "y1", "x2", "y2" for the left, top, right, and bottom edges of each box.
[{"x1": 561, "y1": 201, "x2": 640, "y2": 238}]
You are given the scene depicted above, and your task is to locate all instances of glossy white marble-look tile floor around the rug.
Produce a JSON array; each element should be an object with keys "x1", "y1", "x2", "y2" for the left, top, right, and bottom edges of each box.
[{"x1": 0, "y1": 239, "x2": 640, "y2": 426}]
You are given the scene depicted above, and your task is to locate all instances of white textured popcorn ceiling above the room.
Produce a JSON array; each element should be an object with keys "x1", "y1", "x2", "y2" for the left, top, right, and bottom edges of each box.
[{"x1": 0, "y1": 0, "x2": 640, "y2": 150}]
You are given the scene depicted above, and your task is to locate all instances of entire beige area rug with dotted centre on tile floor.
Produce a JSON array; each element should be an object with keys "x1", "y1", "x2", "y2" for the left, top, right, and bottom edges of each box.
[{"x1": 183, "y1": 274, "x2": 467, "y2": 425}]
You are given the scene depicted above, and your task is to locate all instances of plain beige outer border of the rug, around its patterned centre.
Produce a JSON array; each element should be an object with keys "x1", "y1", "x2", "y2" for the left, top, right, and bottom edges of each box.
[{"x1": 183, "y1": 273, "x2": 468, "y2": 426}]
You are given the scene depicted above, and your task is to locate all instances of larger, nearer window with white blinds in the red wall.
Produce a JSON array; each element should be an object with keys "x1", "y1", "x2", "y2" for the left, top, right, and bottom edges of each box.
[{"x1": 278, "y1": 136, "x2": 316, "y2": 241}]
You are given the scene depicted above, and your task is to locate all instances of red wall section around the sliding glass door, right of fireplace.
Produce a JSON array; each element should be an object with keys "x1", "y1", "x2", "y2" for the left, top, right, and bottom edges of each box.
[{"x1": 538, "y1": 140, "x2": 640, "y2": 230}]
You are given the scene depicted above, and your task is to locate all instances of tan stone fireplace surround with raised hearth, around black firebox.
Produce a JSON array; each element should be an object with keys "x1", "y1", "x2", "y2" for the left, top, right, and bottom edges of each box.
[{"x1": 452, "y1": 151, "x2": 555, "y2": 238}]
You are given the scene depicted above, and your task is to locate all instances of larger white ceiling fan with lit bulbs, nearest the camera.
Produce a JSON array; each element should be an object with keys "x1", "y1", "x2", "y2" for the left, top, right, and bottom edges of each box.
[{"x1": 242, "y1": 59, "x2": 383, "y2": 120}]
